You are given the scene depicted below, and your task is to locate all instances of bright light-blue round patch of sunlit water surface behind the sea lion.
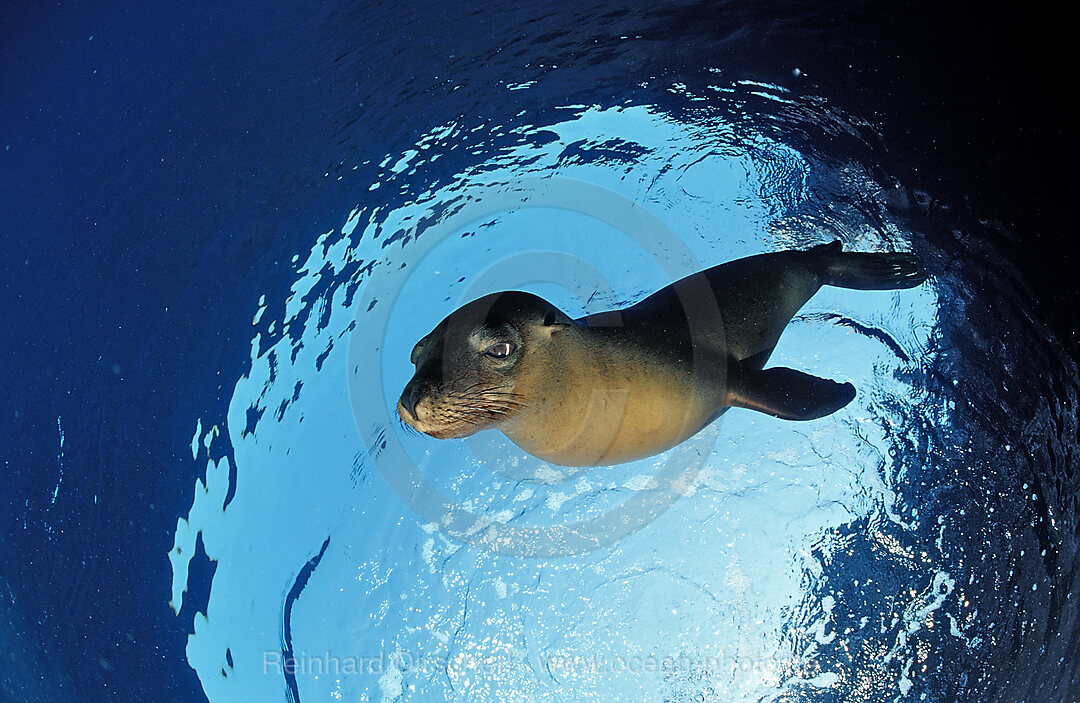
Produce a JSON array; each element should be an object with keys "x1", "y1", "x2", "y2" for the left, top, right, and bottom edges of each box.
[{"x1": 170, "y1": 96, "x2": 962, "y2": 701}]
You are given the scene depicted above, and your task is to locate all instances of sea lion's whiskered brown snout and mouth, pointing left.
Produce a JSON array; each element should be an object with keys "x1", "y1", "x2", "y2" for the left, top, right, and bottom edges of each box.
[{"x1": 397, "y1": 384, "x2": 524, "y2": 440}]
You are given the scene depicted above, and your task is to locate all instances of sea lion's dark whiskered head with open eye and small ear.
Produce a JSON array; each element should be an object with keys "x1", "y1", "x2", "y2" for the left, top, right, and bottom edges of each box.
[{"x1": 397, "y1": 290, "x2": 573, "y2": 440}]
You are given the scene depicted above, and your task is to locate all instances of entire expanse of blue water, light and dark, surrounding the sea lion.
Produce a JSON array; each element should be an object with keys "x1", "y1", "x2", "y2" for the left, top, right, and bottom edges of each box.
[{"x1": 0, "y1": 3, "x2": 1080, "y2": 702}]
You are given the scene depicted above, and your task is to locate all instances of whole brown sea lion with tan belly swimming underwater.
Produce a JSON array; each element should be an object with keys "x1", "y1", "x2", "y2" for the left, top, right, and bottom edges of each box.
[{"x1": 397, "y1": 242, "x2": 927, "y2": 467}]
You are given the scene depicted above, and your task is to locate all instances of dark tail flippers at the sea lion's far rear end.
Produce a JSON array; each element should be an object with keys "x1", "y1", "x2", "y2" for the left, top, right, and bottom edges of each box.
[{"x1": 810, "y1": 242, "x2": 927, "y2": 290}]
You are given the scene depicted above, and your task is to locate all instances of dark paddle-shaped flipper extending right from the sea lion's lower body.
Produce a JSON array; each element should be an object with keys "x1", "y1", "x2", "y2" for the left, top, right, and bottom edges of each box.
[{"x1": 726, "y1": 364, "x2": 855, "y2": 420}]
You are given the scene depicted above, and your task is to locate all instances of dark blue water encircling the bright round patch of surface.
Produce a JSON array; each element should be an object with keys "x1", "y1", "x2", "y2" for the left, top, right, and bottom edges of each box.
[{"x1": 0, "y1": 3, "x2": 1080, "y2": 703}]
